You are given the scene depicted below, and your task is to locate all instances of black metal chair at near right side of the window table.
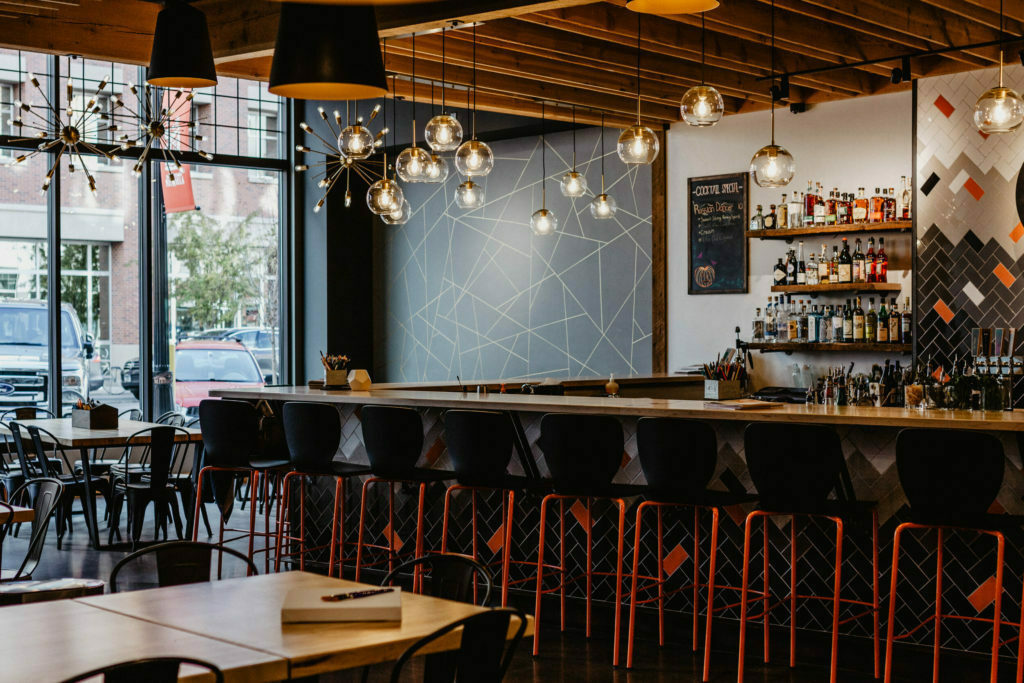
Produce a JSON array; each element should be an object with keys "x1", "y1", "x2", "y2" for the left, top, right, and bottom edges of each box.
[{"x1": 109, "y1": 427, "x2": 188, "y2": 549}]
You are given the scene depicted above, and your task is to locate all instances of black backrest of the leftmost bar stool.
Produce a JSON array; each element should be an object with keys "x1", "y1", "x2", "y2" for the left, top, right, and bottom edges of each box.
[{"x1": 199, "y1": 398, "x2": 259, "y2": 467}]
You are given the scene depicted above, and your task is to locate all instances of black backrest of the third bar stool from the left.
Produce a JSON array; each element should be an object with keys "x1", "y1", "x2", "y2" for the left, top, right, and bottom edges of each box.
[{"x1": 359, "y1": 405, "x2": 423, "y2": 479}]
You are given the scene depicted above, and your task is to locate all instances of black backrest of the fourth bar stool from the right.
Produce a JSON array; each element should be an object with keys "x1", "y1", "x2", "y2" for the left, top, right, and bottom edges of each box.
[{"x1": 538, "y1": 414, "x2": 625, "y2": 494}]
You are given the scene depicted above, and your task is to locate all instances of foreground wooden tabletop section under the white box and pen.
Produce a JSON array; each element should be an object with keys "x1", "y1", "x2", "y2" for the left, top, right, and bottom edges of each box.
[{"x1": 75, "y1": 571, "x2": 534, "y2": 678}]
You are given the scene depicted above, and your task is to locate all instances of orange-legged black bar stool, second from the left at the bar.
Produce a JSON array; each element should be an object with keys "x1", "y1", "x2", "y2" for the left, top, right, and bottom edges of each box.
[{"x1": 274, "y1": 402, "x2": 370, "y2": 578}]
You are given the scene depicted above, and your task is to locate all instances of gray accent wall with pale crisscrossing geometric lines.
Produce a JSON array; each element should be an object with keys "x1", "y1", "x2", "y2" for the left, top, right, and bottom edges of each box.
[{"x1": 374, "y1": 128, "x2": 651, "y2": 382}]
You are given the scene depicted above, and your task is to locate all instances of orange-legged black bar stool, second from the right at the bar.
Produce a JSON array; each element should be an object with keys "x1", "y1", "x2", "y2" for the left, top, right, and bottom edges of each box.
[{"x1": 736, "y1": 423, "x2": 881, "y2": 683}]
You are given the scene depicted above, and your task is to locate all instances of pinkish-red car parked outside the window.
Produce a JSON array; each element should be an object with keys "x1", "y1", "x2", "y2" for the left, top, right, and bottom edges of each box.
[{"x1": 174, "y1": 340, "x2": 264, "y2": 414}]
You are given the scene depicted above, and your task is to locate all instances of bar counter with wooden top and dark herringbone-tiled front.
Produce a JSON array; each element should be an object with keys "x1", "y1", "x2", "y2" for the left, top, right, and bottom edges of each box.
[{"x1": 213, "y1": 383, "x2": 1024, "y2": 656}]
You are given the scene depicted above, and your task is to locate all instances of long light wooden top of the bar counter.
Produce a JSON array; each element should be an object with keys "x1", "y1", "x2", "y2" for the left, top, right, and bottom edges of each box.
[{"x1": 210, "y1": 386, "x2": 1024, "y2": 432}]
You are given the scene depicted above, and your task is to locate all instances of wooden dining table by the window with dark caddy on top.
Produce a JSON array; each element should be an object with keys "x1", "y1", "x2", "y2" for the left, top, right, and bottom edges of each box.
[{"x1": 15, "y1": 418, "x2": 203, "y2": 550}]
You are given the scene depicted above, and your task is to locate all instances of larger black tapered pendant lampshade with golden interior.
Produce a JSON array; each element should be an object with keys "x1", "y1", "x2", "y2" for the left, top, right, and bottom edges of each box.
[{"x1": 268, "y1": 2, "x2": 387, "y2": 99}]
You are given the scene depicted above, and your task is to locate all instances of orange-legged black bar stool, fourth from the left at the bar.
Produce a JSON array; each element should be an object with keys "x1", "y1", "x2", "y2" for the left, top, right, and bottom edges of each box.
[{"x1": 441, "y1": 411, "x2": 551, "y2": 607}]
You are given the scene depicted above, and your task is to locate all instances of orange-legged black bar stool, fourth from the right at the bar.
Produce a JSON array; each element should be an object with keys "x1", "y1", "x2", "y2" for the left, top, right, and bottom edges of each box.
[{"x1": 534, "y1": 414, "x2": 643, "y2": 667}]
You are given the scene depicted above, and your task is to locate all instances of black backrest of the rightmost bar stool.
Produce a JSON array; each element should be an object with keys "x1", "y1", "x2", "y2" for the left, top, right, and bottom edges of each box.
[{"x1": 896, "y1": 429, "x2": 1006, "y2": 525}]
